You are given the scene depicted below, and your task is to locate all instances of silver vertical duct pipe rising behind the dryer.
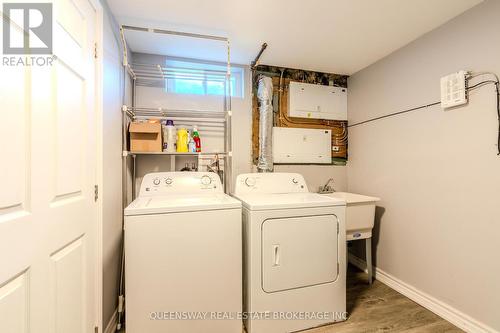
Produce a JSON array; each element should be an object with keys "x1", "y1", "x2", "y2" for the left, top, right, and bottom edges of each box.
[{"x1": 257, "y1": 75, "x2": 273, "y2": 172}]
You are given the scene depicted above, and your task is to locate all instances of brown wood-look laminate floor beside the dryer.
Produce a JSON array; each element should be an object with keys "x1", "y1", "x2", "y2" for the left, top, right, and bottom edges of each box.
[{"x1": 122, "y1": 266, "x2": 463, "y2": 333}]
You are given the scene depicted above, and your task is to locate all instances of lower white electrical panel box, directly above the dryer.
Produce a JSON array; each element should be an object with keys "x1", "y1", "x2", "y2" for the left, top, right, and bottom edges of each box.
[{"x1": 273, "y1": 127, "x2": 332, "y2": 164}]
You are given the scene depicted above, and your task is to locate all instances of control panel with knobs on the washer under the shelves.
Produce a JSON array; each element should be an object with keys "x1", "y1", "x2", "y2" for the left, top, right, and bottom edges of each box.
[{"x1": 139, "y1": 172, "x2": 224, "y2": 196}]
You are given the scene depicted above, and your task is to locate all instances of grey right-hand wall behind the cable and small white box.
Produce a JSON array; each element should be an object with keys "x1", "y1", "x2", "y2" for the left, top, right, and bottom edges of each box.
[{"x1": 348, "y1": 0, "x2": 500, "y2": 330}]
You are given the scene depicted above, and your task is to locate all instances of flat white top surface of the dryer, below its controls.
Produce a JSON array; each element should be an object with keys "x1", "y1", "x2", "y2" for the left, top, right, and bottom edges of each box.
[{"x1": 236, "y1": 193, "x2": 346, "y2": 210}]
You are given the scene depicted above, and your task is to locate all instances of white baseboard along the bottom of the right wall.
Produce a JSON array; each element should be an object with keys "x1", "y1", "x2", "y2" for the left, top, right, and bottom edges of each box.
[{"x1": 349, "y1": 253, "x2": 500, "y2": 333}]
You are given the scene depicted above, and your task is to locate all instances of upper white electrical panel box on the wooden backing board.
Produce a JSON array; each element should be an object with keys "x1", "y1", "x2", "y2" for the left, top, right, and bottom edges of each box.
[{"x1": 288, "y1": 82, "x2": 347, "y2": 120}]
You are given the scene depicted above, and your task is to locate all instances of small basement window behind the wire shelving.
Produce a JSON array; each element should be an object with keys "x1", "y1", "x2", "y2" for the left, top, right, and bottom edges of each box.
[{"x1": 165, "y1": 59, "x2": 244, "y2": 98}]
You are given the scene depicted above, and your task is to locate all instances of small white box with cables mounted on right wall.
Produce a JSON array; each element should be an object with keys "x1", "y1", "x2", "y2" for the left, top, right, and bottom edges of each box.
[{"x1": 441, "y1": 71, "x2": 467, "y2": 109}]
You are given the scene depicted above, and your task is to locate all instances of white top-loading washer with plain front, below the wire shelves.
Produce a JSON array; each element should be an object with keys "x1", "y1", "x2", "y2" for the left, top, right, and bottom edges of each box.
[{"x1": 125, "y1": 172, "x2": 242, "y2": 333}]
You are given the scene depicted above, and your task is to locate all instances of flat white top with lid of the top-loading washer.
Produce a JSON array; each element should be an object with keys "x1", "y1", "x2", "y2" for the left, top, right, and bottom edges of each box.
[{"x1": 125, "y1": 193, "x2": 241, "y2": 216}]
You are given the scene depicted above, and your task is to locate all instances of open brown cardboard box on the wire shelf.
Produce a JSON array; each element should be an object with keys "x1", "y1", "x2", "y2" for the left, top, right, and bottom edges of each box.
[{"x1": 128, "y1": 122, "x2": 162, "y2": 153}]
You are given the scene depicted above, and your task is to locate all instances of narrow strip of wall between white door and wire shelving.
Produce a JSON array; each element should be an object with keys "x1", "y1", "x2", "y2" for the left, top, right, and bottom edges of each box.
[{"x1": 100, "y1": 1, "x2": 123, "y2": 327}]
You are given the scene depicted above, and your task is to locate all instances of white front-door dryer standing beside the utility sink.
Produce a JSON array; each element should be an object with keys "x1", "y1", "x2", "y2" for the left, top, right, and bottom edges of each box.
[{"x1": 235, "y1": 173, "x2": 346, "y2": 333}]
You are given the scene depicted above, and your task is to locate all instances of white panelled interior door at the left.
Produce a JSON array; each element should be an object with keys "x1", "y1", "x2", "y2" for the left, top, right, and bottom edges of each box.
[{"x1": 0, "y1": 0, "x2": 98, "y2": 333}]
